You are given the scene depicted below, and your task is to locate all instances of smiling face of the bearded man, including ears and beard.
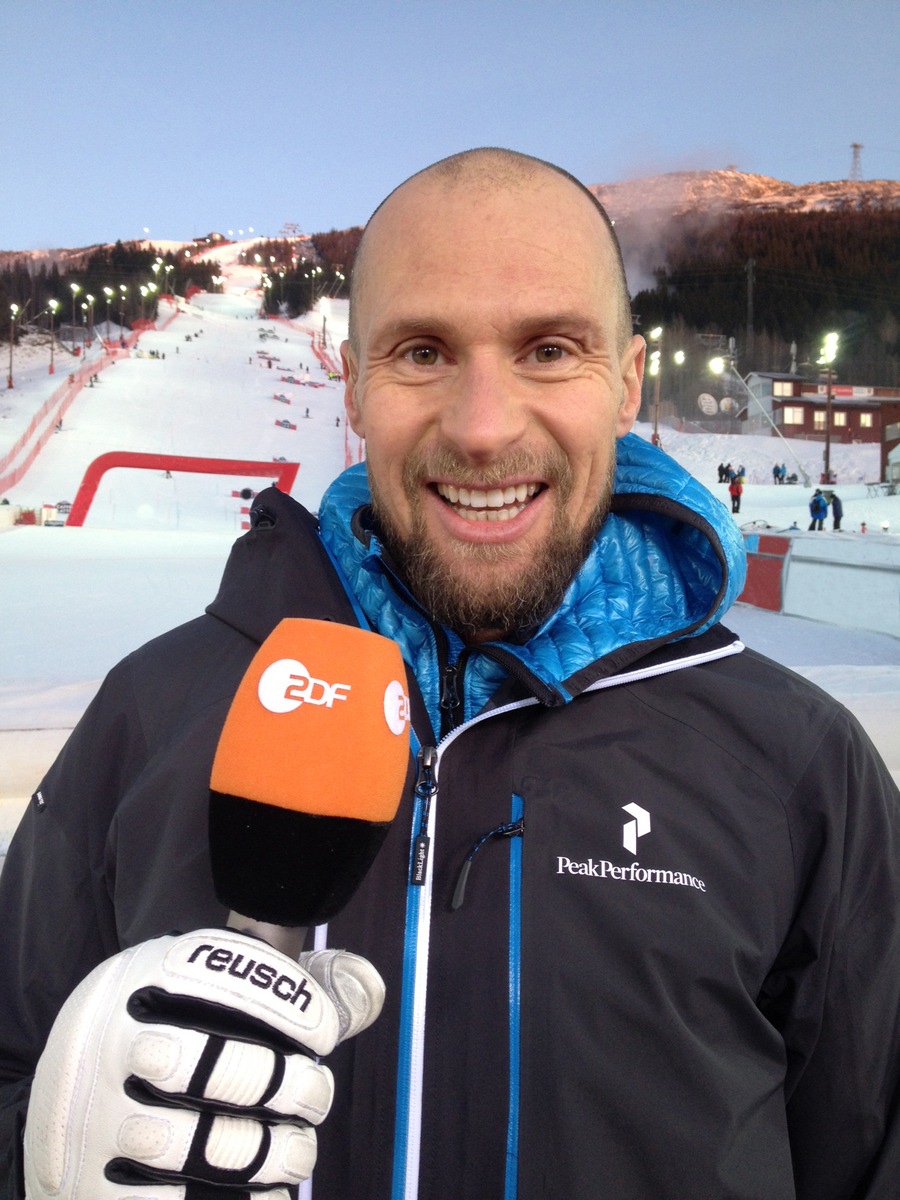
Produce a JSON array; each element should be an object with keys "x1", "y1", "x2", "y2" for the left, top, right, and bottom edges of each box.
[{"x1": 342, "y1": 172, "x2": 643, "y2": 641}]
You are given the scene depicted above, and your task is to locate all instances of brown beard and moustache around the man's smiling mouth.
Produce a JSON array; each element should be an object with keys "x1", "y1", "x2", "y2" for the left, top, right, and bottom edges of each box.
[{"x1": 370, "y1": 448, "x2": 616, "y2": 643}]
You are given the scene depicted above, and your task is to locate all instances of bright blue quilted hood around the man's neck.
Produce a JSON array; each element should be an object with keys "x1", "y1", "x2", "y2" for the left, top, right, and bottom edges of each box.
[{"x1": 319, "y1": 433, "x2": 746, "y2": 727}]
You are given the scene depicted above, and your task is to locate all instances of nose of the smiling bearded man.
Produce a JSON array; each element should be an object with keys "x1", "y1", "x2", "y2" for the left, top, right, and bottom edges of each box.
[{"x1": 440, "y1": 354, "x2": 528, "y2": 462}]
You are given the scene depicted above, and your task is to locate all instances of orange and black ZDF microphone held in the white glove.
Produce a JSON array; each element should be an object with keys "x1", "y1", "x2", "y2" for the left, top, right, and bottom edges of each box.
[{"x1": 209, "y1": 618, "x2": 409, "y2": 958}]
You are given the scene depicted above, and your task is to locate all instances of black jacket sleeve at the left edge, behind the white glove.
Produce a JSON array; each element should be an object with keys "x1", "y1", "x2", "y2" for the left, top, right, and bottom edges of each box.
[{"x1": 0, "y1": 660, "x2": 150, "y2": 1200}]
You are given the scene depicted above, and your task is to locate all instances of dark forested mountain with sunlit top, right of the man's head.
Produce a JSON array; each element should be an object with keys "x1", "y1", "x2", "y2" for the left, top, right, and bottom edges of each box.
[{"x1": 590, "y1": 168, "x2": 900, "y2": 386}]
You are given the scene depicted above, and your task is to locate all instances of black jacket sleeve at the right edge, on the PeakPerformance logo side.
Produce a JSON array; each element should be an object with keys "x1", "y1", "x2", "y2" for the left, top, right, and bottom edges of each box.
[{"x1": 761, "y1": 709, "x2": 900, "y2": 1200}]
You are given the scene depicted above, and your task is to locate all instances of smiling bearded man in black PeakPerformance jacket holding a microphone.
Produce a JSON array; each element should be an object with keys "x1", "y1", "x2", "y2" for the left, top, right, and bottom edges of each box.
[{"x1": 0, "y1": 150, "x2": 900, "y2": 1200}]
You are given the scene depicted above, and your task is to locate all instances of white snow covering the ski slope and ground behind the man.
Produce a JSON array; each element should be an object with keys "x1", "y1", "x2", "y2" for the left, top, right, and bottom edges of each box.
[{"x1": 0, "y1": 258, "x2": 900, "y2": 854}]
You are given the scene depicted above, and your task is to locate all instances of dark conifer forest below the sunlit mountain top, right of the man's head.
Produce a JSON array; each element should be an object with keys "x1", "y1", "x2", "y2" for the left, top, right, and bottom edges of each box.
[{"x1": 617, "y1": 209, "x2": 900, "y2": 386}]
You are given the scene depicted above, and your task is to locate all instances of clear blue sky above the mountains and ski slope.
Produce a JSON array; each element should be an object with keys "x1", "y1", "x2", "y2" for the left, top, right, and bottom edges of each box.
[{"x1": 0, "y1": 0, "x2": 900, "y2": 250}]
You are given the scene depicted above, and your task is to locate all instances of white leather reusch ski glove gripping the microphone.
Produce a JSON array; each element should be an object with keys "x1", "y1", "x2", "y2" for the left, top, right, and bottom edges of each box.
[{"x1": 25, "y1": 929, "x2": 384, "y2": 1200}]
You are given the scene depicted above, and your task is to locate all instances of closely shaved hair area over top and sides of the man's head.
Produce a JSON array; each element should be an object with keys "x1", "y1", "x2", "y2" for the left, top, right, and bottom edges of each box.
[{"x1": 349, "y1": 146, "x2": 631, "y2": 354}]
